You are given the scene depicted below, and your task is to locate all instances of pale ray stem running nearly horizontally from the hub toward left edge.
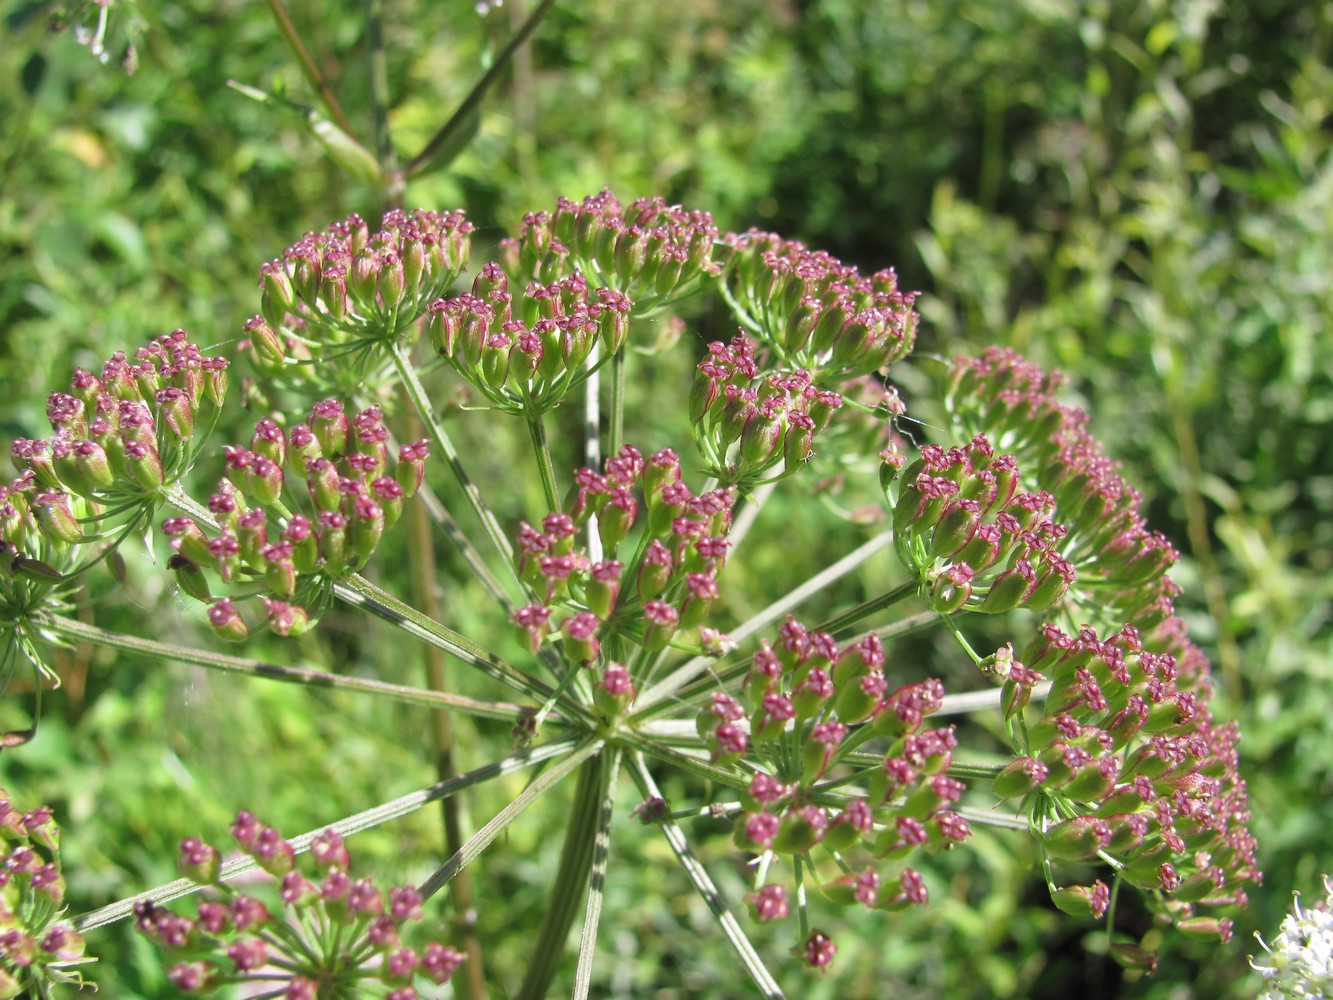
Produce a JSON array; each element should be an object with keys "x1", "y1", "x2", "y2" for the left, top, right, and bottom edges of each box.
[{"x1": 36, "y1": 615, "x2": 535, "y2": 721}]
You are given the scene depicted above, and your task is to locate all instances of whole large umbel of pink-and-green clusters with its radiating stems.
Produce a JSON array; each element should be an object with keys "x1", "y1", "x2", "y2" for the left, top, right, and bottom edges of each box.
[{"x1": 0, "y1": 191, "x2": 1263, "y2": 1000}]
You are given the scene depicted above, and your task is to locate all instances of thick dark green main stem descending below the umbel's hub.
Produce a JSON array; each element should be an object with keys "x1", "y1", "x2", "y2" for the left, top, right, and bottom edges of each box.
[{"x1": 517, "y1": 753, "x2": 615, "y2": 1000}]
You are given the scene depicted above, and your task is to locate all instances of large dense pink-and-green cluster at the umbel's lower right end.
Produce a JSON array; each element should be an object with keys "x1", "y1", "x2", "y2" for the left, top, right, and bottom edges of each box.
[{"x1": 989, "y1": 624, "x2": 1260, "y2": 939}]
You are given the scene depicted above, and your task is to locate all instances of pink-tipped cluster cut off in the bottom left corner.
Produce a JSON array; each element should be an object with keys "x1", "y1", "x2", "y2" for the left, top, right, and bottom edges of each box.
[{"x1": 0, "y1": 788, "x2": 92, "y2": 999}]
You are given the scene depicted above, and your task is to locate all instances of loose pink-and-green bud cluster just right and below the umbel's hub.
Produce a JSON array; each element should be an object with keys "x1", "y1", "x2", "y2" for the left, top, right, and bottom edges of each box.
[{"x1": 696, "y1": 617, "x2": 970, "y2": 944}]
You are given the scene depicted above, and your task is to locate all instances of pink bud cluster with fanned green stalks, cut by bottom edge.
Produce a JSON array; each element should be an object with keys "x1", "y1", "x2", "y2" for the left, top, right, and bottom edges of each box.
[{"x1": 135, "y1": 812, "x2": 467, "y2": 1000}]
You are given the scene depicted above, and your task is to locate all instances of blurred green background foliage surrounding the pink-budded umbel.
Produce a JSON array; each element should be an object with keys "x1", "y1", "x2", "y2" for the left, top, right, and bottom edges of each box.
[{"x1": 0, "y1": 0, "x2": 1333, "y2": 997}]
